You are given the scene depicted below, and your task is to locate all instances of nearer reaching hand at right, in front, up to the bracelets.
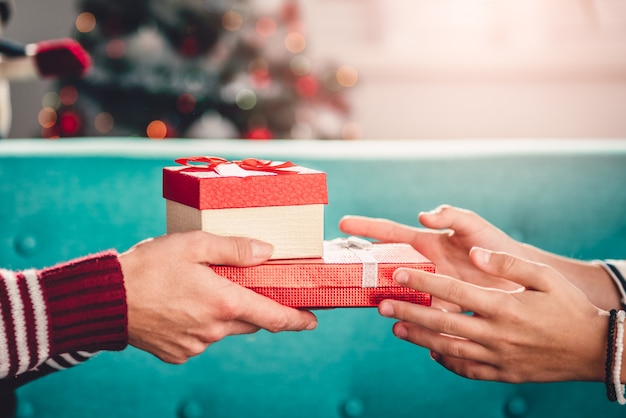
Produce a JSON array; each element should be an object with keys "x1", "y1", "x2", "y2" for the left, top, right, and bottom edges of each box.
[{"x1": 379, "y1": 248, "x2": 608, "y2": 383}]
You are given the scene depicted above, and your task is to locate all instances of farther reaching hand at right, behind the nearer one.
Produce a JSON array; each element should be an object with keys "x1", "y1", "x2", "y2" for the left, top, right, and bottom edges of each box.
[{"x1": 339, "y1": 205, "x2": 619, "y2": 311}]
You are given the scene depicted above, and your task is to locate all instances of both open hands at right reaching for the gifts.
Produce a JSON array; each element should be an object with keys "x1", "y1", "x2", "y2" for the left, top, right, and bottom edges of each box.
[{"x1": 339, "y1": 206, "x2": 620, "y2": 382}]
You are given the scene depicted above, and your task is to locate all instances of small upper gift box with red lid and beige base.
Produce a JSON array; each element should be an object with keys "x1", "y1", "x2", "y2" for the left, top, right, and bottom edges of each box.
[{"x1": 163, "y1": 157, "x2": 328, "y2": 259}]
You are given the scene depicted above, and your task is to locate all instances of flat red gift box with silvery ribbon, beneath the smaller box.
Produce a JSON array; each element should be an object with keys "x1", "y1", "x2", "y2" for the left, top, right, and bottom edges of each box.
[{"x1": 212, "y1": 237, "x2": 435, "y2": 308}]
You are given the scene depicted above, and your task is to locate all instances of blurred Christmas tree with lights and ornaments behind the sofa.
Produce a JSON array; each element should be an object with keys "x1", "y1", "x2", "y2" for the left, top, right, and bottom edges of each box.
[{"x1": 39, "y1": 0, "x2": 357, "y2": 139}]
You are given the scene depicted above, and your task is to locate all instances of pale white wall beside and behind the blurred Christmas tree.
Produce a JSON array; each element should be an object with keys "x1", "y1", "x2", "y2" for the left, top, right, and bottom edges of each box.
[{"x1": 5, "y1": 0, "x2": 626, "y2": 138}]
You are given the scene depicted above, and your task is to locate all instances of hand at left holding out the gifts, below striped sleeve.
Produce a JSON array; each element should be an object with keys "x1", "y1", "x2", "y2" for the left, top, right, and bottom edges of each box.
[{"x1": 119, "y1": 231, "x2": 317, "y2": 363}]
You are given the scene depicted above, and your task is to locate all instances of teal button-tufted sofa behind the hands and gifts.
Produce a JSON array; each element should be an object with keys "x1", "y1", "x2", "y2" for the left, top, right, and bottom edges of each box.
[{"x1": 0, "y1": 138, "x2": 626, "y2": 418}]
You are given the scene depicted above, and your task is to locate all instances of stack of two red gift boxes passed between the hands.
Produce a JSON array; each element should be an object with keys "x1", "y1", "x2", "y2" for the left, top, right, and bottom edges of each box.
[{"x1": 163, "y1": 157, "x2": 434, "y2": 308}]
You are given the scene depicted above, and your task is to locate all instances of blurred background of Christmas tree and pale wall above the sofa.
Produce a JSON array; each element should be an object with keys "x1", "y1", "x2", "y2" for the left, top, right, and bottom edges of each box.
[{"x1": 4, "y1": 0, "x2": 626, "y2": 139}]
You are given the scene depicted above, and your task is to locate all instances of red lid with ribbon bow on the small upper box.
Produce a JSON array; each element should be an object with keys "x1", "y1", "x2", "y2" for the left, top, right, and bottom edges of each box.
[{"x1": 163, "y1": 157, "x2": 328, "y2": 210}]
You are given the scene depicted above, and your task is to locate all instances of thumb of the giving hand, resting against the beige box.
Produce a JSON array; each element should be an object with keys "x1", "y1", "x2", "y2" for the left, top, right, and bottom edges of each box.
[{"x1": 186, "y1": 231, "x2": 274, "y2": 267}]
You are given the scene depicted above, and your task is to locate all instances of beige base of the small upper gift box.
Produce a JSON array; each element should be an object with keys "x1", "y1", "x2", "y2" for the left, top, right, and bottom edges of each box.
[{"x1": 165, "y1": 199, "x2": 324, "y2": 260}]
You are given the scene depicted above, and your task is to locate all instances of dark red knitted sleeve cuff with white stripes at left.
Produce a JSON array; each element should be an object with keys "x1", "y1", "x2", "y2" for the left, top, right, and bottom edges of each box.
[{"x1": 0, "y1": 251, "x2": 128, "y2": 387}]
